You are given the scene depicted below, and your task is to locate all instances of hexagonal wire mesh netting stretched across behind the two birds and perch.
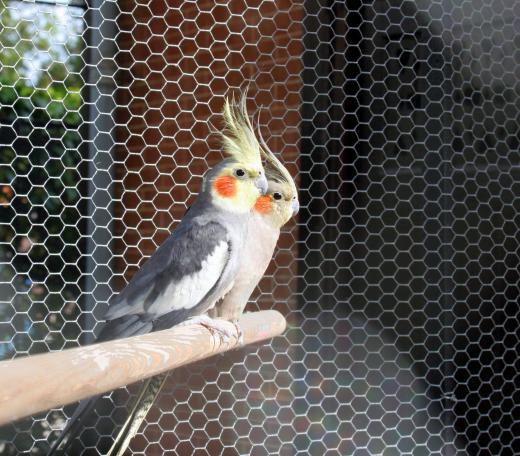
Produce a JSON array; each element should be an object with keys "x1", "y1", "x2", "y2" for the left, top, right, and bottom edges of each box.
[{"x1": 0, "y1": 0, "x2": 520, "y2": 456}]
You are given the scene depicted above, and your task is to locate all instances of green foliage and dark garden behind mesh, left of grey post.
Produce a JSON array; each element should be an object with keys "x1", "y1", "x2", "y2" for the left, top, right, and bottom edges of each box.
[{"x1": 0, "y1": 2, "x2": 88, "y2": 454}]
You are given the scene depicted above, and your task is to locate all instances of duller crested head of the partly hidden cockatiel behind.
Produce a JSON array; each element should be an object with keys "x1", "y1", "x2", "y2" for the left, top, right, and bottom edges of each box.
[{"x1": 255, "y1": 124, "x2": 300, "y2": 228}]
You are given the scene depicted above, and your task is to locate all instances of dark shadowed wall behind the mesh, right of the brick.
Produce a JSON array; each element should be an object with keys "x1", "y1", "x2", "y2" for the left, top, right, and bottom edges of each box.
[{"x1": 300, "y1": 1, "x2": 520, "y2": 454}]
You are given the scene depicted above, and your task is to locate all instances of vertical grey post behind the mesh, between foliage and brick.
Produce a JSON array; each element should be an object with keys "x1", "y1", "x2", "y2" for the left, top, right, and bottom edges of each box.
[{"x1": 82, "y1": 0, "x2": 117, "y2": 343}]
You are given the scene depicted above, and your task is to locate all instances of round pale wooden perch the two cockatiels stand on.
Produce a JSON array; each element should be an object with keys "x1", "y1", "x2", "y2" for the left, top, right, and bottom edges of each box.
[{"x1": 0, "y1": 310, "x2": 285, "y2": 425}]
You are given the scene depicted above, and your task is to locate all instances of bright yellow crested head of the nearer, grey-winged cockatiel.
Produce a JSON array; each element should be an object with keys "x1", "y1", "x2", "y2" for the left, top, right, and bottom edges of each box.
[{"x1": 204, "y1": 96, "x2": 267, "y2": 213}]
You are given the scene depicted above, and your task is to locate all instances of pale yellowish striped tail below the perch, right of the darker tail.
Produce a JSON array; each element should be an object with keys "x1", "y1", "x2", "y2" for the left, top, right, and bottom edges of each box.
[{"x1": 107, "y1": 373, "x2": 168, "y2": 456}]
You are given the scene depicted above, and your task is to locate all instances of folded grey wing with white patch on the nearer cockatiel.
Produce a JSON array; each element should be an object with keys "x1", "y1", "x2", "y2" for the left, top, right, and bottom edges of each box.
[{"x1": 99, "y1": 218, "x2": 231, "y2": 340}]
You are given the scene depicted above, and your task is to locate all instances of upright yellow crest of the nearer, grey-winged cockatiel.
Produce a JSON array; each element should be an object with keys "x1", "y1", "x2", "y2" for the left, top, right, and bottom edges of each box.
[{"x1": 222, "y1": 95, "x2": 262, "y2": 167}]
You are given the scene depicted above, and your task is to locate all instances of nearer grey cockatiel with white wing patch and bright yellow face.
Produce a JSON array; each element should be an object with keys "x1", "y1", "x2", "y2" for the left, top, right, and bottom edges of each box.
[{"x1": 49, "y1": 97, "x2": 267, "y2": 455}]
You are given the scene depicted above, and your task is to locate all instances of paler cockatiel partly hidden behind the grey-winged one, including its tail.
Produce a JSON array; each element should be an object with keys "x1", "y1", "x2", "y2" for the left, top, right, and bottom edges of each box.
[{"x1": 108, "y1": 131, "x2": 300, "y2": 456}]
